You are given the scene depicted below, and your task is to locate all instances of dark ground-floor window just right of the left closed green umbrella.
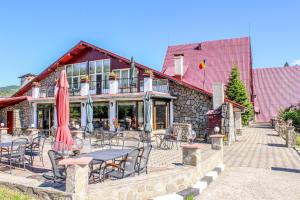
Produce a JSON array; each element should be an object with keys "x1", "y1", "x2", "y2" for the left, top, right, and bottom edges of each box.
[{"x1": 93, "y1": 102, "x2": 109, "y2": 130}]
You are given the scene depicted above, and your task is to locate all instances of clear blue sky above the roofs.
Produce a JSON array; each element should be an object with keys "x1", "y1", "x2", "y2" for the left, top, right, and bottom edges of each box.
[{"x1": 0, "y1": 0, "x2": 300, "y2": 86}]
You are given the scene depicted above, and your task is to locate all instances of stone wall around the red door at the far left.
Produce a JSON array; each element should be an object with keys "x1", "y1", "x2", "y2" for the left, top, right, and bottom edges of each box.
[{"x1": 0, "y1": 101, "x2": 33, "y2": 131}]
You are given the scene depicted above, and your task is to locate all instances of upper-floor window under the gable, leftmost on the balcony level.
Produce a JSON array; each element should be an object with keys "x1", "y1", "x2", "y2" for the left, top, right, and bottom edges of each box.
[{"x1": 66, "y1": 62, "x2": 87, "y2": 89}]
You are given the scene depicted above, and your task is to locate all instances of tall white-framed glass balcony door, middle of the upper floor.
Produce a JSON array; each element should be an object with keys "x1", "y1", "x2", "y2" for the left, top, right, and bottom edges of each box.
[{"x1": 89, "y1": 59, "x2": 110, "y2": 94}]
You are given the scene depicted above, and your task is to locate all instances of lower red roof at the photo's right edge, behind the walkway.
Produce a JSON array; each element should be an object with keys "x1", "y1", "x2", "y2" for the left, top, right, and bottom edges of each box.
[{"x1": 253, "y1": 67, "x2": 300, "y2": 122}]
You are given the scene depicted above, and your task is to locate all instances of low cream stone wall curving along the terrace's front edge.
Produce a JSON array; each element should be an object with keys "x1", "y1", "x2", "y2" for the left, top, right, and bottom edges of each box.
[{"x1": 89, "y1": 150, "x2": 223, "y2": 200}]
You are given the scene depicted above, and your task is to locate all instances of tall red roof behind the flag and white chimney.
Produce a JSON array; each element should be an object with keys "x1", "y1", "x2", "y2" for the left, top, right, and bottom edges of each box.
[{"x1": 162, "y1": 37, "x2": 252, "y2": 94}]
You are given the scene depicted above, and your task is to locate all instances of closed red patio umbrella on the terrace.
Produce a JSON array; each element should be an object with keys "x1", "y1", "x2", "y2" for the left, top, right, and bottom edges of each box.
[{"x1": 55, "y1": 70, "x2": 73, "y2": 150}]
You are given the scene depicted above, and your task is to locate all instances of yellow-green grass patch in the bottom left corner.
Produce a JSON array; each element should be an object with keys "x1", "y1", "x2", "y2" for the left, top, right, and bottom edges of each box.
[{"x1": 0, "y1": 186, "x2": 34, "y2": 200}]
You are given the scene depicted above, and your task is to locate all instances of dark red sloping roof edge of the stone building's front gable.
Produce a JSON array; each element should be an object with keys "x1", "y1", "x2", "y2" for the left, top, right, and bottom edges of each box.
[{"x1": 13, "y1": 41, "x2": 245, "y2": 109}]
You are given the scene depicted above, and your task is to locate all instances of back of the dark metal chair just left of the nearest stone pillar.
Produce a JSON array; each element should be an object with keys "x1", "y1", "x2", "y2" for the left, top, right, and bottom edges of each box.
[{"x1": 48, "y1": 150, "x2": 65, "y2": 179}]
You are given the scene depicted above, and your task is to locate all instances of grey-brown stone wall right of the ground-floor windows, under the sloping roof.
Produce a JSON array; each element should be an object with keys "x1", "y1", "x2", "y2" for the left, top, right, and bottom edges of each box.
[{"x1": 169, "y1": 82, "x2": 213, "y2": 135}]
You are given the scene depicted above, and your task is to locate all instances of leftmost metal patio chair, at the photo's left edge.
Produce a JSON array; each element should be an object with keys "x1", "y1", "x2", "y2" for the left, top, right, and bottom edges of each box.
[{"x1": 2, "y1": 138, "x2": 28, "y2": 173}]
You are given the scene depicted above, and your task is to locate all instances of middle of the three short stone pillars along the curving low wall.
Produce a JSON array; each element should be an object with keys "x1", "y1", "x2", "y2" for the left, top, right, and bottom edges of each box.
[{"x1": 182, "y1": 144, "x2": 201, "y2": 169}]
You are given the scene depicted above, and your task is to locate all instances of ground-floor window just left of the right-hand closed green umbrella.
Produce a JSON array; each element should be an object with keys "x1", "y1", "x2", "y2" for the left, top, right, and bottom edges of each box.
[{"x1": 117, "y1": 101, "x2": 144, "y2": 130}]
